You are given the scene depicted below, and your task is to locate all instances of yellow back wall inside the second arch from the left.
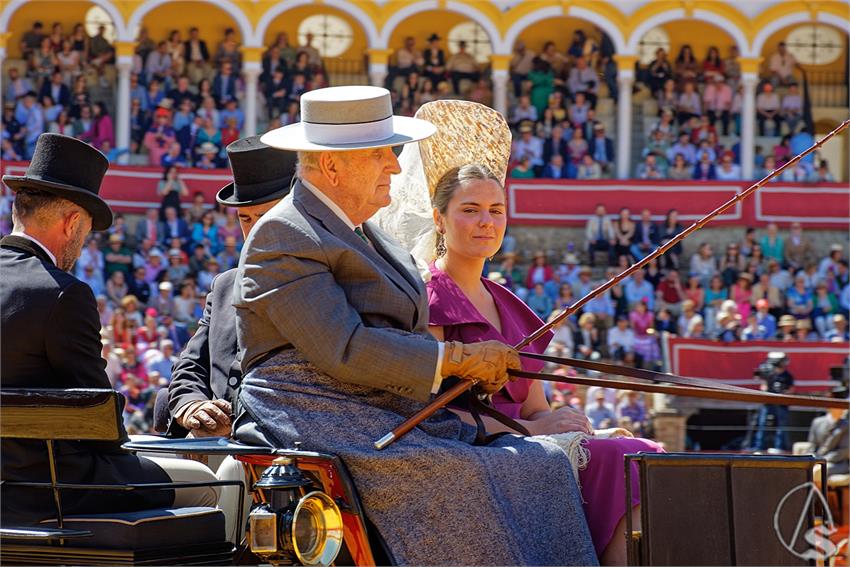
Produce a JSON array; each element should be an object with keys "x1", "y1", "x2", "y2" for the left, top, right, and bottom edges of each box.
[{"x1": 135, "y1": 2, "x2": 244, "y2": 44}]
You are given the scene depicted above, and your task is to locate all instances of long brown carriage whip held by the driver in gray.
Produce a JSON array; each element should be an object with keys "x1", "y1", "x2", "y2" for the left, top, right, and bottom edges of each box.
[{"x1": 375, "y1": 119, "x2": 850, "y2": 449}]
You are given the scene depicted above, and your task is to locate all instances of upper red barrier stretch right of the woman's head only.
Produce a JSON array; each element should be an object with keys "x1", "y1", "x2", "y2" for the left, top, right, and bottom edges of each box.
[{"x1": 508, "y1": 179, "x2": 850, "y2": 230}]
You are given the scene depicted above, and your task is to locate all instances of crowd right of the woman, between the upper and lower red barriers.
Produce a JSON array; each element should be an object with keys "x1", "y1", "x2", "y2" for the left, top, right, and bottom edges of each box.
[{"x1": 491, "y1": 209, "x2": 850, "y2": 378}]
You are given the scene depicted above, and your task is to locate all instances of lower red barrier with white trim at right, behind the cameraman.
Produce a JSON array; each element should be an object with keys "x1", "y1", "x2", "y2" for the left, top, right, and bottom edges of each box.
[{"x1": 663, "y1": 336, "x2": 850, "y2": 392}]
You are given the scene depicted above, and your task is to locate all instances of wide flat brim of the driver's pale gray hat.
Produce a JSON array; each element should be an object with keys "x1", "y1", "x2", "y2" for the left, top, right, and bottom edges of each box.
[{"x1": 260, "y1": 116, "x2": 437, "y2": 152}]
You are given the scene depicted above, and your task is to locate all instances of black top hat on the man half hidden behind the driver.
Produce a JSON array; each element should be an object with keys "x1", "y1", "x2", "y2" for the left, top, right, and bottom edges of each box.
[{"x1": 215, "y1": 136, "x2": 298, "y2": 207}]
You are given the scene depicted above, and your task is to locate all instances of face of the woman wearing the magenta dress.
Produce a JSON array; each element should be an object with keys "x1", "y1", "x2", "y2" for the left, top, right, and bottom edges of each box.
[{"x1": 434, "y1": 179, "x2": 507, "y2": 258}]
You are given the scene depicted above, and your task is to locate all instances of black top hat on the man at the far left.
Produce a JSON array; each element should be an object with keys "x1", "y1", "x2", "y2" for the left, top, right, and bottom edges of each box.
[{"x1": 3, "y1": 133, "x2": 112, "y2": 230}]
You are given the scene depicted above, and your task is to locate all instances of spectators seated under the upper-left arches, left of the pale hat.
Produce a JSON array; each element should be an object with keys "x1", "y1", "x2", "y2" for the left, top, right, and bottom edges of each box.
[{"x1": 2, "y1": 22, "x2": 327, "y2": 169}]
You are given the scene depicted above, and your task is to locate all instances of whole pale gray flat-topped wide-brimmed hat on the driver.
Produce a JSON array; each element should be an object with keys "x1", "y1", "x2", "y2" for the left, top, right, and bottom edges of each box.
[{"x1": 260, "y1": 86, "x2": 436, "y2": 152}]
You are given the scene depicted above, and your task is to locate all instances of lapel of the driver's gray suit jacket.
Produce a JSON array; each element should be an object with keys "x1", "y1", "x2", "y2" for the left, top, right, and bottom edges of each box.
[{"x1": 292, "y1": 182, "x2": 421, "y2": 306}]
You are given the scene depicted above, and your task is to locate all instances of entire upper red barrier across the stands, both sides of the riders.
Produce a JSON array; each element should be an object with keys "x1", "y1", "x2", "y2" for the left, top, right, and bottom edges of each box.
[{"x1": 0, "y1": 162, "x2": 850, "y2": 226}]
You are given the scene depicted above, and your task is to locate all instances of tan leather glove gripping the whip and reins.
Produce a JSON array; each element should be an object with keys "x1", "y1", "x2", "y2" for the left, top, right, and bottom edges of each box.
[{"x1": 440, "y1": 341, "x2": 520, "y2": 394}]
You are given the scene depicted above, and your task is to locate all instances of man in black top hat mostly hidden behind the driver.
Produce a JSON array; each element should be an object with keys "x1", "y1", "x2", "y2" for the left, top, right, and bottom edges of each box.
[{"x1": 167, "y1": 136, "x2": 296, "y2": 436}]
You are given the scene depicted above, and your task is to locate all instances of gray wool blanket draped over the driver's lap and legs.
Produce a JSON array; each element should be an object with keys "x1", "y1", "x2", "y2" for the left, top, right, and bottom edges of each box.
[{"x1": 236, "y1": 349, "x2": 598, "y2": 565}]
